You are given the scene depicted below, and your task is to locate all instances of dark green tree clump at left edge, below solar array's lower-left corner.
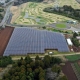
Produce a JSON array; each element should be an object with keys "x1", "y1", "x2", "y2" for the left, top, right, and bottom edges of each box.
[{"x1": 0, "y1": 56, "x2": 12, "y2": 67}]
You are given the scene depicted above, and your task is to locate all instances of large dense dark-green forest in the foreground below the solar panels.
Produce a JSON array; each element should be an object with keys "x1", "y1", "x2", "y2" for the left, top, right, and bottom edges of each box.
[{"x1": 2, "y1": 55, "x2": 67, "y2": 80}]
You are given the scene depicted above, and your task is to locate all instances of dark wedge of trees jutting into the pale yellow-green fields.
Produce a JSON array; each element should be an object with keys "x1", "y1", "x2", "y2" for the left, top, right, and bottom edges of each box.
[{"x1": 43, "y1": 5, "x2": 80, "y2": 21}]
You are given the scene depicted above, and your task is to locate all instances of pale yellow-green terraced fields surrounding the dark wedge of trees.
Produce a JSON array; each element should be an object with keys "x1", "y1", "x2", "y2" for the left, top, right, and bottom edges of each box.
[{"x1": 10, "y1": 0, "x2": 80, "y2": 25}]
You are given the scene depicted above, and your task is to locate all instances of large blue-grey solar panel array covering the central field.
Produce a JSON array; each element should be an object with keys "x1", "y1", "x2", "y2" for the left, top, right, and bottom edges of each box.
[{"x1": 3, "y1": 27, "x2": 69, "y2": 56}]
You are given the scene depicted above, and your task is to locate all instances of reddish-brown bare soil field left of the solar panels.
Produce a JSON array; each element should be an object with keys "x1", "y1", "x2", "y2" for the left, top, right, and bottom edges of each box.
[{"x1": 0, "y1": 27, "x2": 14, "y2": 56}]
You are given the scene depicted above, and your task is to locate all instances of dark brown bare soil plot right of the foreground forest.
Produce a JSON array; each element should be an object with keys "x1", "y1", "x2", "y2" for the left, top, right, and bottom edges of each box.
[{"x1": 62, "y1": 62, "x2": 77, "y2": 80}]
